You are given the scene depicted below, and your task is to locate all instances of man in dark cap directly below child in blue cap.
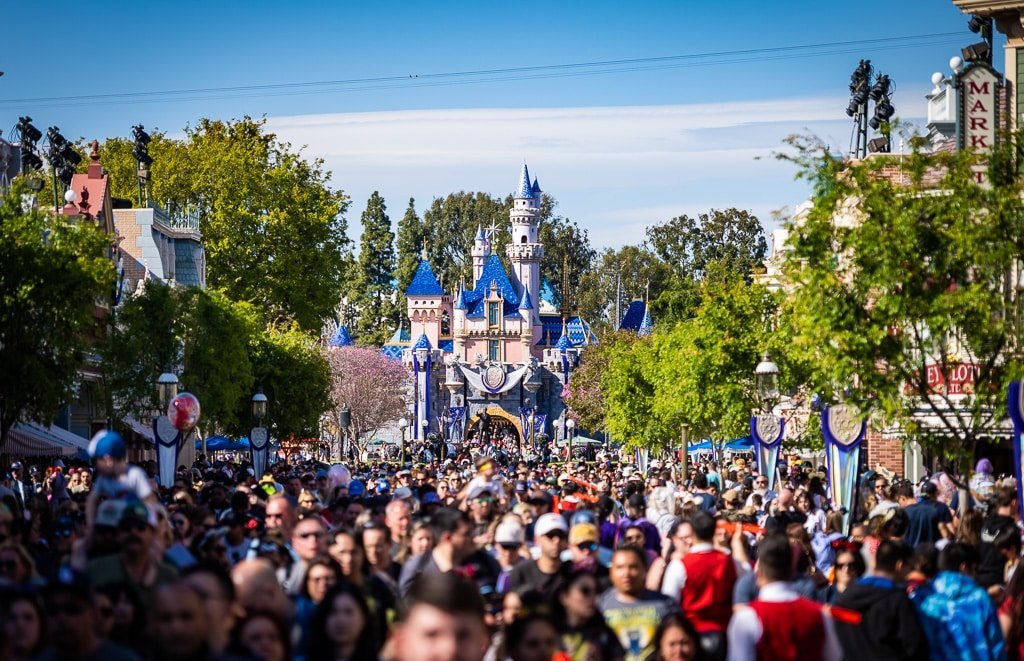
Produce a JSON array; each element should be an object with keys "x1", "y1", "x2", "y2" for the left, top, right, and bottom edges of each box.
[{"x1": 87, "y1": 500, "x2": 177, "y2": 612}]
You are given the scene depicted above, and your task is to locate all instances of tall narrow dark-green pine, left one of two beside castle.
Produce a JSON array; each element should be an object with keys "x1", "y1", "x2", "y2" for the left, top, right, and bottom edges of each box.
[{"x1": 351, "y1": 190, "x2": 397, "y2": 346}]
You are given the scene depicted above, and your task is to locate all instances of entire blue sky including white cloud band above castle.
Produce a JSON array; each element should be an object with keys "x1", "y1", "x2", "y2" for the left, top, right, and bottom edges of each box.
[{"x1": 0, "y1": 0, "x2": 987, "y2": 247}]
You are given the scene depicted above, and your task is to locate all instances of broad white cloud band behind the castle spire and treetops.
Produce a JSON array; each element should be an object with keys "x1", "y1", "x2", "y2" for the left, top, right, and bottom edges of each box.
[{"x1": 268, "y1": 97, "x2": 925, "y2": 251}]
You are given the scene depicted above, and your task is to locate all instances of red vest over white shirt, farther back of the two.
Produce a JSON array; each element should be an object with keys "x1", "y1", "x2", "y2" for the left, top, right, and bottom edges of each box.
[{"x1": 679, "y1": 550, "x2": 736, "y2": 633}]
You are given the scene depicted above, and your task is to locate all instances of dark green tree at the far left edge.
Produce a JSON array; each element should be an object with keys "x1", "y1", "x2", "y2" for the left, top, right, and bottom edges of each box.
[{"x1": 0, "y1": 181, "x2": 115, "y2": 442}]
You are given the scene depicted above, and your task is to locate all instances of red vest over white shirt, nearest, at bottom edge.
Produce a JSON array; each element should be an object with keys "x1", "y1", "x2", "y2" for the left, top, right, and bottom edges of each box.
[{"x1": 749, "y1": 597, "x2": 825, "y2": 661}]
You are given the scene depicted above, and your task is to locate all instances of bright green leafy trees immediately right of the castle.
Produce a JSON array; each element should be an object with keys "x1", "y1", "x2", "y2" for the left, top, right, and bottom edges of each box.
[{"x1": 587, "y1": 274, "x2": 778, "y2": 448}]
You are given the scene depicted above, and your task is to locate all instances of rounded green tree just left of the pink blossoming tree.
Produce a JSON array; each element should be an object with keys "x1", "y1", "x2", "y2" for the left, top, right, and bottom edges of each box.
[{"x1": 247, "y1": 324, "x2": 331, "y2": 438}]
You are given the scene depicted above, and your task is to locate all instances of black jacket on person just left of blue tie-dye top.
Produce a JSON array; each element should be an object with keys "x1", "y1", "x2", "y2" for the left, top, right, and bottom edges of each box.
[{"x1": 833, "y1": 577, "x2": 928, "y2": 661}]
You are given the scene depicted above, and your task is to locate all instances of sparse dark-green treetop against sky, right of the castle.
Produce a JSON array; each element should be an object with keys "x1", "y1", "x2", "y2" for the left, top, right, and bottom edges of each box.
[{"x1": 647, "y1": 209, "x2": 768, "y2": 280}]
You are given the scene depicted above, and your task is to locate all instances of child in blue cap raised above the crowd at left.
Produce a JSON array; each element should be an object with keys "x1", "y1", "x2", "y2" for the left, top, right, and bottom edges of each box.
[{"x1": 85, "y1": 430, "x2": 157, "y2": 527}]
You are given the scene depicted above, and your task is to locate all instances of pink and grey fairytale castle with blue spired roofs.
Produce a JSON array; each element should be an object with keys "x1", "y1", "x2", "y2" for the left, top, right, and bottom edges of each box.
[{"x1": 383, "y1": 165, "x2": 595, "y2": 450}]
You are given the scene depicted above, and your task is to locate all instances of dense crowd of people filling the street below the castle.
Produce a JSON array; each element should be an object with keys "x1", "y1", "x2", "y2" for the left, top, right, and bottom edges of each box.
[{"x1": 0, "y1": 432, "x2": 1024, "y2": 661}]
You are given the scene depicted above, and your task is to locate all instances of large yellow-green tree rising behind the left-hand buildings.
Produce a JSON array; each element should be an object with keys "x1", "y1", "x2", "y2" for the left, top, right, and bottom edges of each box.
[{"x1": 101, "y1": 117, "x2": 350, "y2": 332}]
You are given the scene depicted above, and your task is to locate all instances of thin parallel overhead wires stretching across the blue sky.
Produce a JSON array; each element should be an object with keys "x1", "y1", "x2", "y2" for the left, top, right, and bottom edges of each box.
[{"x1": 0, "y1": 32, "x2": 963, "y2": 107}]
